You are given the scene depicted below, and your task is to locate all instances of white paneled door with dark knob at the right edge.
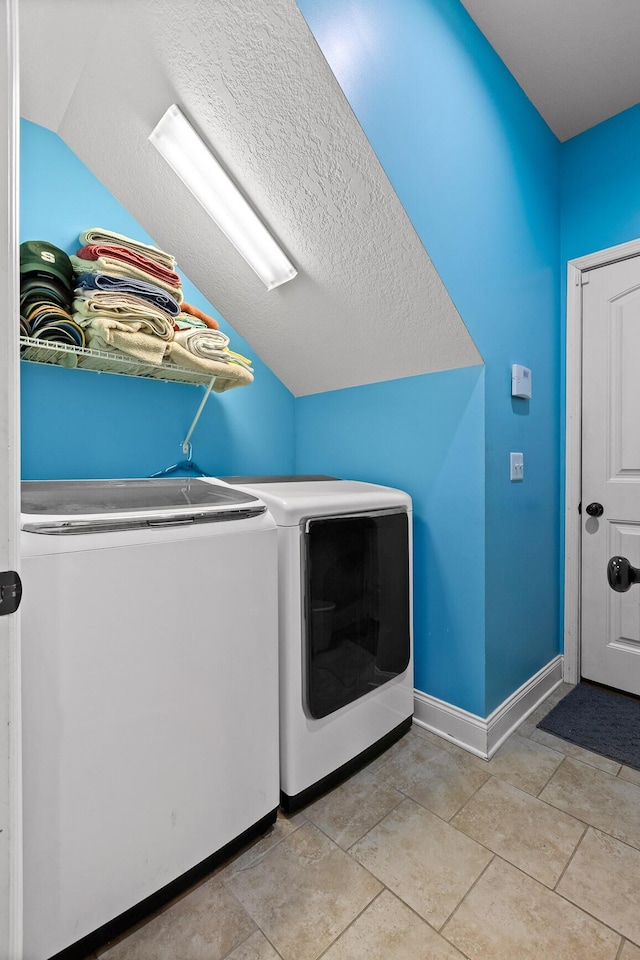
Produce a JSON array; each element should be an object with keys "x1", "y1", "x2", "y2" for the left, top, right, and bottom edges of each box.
[{"x1": 581, "y1": 251, "x2": 640, "y2": 694}]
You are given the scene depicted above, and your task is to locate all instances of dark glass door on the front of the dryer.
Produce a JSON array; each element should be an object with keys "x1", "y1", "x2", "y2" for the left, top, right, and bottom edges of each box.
[{"x1": 304, "y1": 510, "x2": 411, "y2": 719}]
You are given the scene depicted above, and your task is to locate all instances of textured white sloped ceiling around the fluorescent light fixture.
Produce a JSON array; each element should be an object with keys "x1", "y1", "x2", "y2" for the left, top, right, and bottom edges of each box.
[{"x1": 20, "y1": 0, "x2": 482, "y2": 396}]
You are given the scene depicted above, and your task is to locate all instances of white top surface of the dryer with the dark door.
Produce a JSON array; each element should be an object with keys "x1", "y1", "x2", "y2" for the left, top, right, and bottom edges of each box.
[{"x1": 223, "y1": 475, "x2": 411, "y2": 526}]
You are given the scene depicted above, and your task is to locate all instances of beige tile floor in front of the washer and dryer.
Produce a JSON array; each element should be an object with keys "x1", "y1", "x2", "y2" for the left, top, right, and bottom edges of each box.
[{"x1": 91, "y1": 685, "x2": 640, "y2": 960}]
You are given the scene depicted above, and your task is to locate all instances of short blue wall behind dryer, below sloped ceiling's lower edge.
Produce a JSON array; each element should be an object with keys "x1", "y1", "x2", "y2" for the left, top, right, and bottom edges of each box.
[{"x1": 297, "y1": 367, "x2": 485, "y2": 715}]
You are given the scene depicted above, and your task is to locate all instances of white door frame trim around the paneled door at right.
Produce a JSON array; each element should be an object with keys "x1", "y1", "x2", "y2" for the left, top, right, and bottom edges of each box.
[{"x1": 563, "y1": 239, "x2": 640, "y2": 683}]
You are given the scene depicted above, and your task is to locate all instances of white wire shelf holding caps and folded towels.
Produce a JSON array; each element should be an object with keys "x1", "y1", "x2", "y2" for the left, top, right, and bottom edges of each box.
[{"x1": 20, "y1": 337, "x2": 219, "y2": 386}]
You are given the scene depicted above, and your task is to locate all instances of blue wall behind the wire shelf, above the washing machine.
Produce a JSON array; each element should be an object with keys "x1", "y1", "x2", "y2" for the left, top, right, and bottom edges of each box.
[{"x1": 20, "y1": 121, "x2": 295, "y2": 479}]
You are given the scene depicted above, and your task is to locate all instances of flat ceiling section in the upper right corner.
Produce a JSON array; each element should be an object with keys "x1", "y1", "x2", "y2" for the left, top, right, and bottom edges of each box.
[{"x1": 461, "y1": 0, "x2": 640, "y2": 141}]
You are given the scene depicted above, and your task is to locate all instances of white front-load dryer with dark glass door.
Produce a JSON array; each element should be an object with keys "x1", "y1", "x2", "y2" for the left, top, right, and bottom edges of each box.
[{"x1": 224, "y1": 476, "x2": 413, "y2": 812}]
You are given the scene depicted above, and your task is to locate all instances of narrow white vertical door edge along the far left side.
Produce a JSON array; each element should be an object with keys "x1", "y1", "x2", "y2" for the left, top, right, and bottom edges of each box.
[{"x1": 0, "y1": 0, "x2": 23, "y2": 960}]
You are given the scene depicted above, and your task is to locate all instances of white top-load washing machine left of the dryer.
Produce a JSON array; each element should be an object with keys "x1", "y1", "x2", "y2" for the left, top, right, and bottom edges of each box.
[{"x1": 21, "y1": 478, "x2": 279, "y2": 960}]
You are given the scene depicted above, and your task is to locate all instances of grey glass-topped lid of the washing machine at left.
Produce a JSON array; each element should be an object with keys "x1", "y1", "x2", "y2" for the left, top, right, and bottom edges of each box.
[{"x1": 21, "y1": 477, "x2": 266, "y2": 534}]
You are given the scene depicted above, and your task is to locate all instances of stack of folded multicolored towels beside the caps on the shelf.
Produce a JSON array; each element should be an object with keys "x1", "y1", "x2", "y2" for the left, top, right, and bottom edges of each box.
[{"x1": 70, "y1": 227, "x2": 253, "y2": 392}]
